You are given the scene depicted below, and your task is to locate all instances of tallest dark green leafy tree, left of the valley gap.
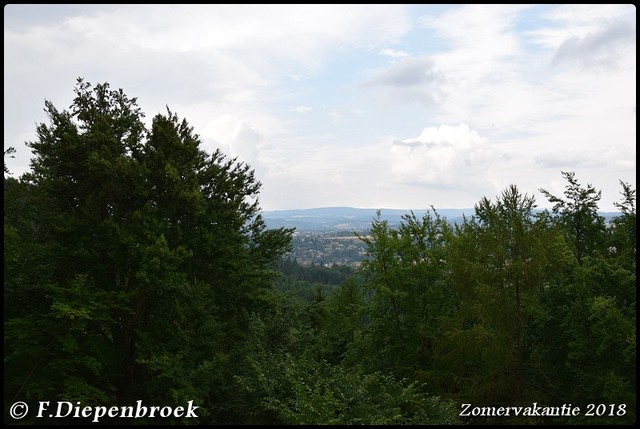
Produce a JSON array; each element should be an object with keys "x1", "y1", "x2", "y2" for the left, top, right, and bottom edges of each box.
[{"x1": 5, "y1": 79, "x2": 292, "y2": 422}]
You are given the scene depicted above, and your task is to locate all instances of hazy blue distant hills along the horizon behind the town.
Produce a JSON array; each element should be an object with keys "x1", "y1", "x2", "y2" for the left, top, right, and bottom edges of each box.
[{"x1": 262, "y1": 207, "x2": 620, "y2": 231}]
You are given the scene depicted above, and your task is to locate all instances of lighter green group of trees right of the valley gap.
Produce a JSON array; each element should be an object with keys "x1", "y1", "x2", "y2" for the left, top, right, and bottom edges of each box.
[{"x1": 331, "y1": 178, "x2": 636, "y2": 424}]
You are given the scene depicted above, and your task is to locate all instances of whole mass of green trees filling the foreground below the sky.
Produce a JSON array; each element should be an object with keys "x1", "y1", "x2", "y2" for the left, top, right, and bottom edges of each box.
[{"x1": 4, "y1": 79, "x2": 636, "y2": 425}]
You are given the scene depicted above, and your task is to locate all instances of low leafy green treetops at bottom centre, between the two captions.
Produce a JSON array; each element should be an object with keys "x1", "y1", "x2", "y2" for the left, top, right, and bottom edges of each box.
[{"x1": 238, "y1": 353, "x2": 460, "y2": 425}]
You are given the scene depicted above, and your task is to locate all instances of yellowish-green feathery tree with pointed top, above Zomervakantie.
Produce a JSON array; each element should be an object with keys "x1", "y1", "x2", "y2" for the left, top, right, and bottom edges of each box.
[{"x1": 435, "y1": 185, "x2": 570, "y2": 416}]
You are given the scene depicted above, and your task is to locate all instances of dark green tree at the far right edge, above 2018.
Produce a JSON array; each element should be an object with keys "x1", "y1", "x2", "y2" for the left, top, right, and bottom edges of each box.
[{"x1": 538, "y1": 176, "x2": 636, "y2": 424}]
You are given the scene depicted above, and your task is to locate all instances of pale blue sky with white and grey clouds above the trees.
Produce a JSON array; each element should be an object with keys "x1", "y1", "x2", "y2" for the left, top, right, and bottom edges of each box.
[{"x1": 4, "y1": 4, "x2": 636, "y2": 211}]
